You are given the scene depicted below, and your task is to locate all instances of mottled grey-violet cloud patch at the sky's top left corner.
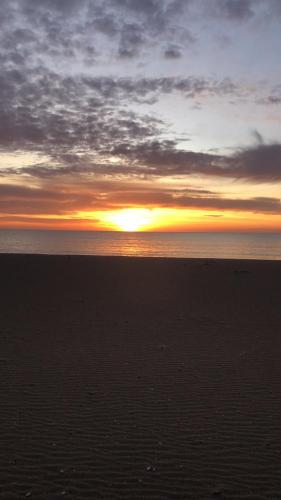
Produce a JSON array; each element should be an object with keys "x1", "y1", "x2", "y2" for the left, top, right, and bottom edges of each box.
[{"x1": 0, "y1": 0, "x2": 192, "y2": 61}]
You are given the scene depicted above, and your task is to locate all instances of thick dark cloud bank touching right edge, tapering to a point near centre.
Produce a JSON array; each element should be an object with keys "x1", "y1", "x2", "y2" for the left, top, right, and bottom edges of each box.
[{"x1": 110, "y1": 141, "x2": 281, "y2": 183}]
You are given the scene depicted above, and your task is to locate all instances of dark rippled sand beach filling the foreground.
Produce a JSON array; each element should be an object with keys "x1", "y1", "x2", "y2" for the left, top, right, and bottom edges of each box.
[{"x1": 0, "y1": 255, "x2": 281, "y2": 500}]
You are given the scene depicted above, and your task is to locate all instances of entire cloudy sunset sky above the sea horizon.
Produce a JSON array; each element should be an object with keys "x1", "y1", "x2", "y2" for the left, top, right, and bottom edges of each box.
[{"x1": 0, "y1": 0, "x2": 281, "y2": 231}]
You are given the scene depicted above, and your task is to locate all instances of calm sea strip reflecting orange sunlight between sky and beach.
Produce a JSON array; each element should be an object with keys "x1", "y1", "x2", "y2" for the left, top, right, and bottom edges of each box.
[{"x1": 0, "y1": 229, "x2": 281, "y2": 260}]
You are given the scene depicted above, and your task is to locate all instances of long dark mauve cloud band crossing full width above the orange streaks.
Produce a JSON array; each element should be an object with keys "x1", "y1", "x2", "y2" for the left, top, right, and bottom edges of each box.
[{"x1": 0, "y1": 140, "x2": 281, "y2": 184}]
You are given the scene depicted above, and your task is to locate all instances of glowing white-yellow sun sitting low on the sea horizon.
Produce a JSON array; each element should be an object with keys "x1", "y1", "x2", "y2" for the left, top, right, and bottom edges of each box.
[{"x1": 110, "y1": 208, "x2": 152, "y2": 232}]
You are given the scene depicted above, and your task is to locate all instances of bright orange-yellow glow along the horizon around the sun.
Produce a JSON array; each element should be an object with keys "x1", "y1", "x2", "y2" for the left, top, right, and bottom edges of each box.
[{"x1": 0, "y1": 207, "x2": 281, "y2": 232}]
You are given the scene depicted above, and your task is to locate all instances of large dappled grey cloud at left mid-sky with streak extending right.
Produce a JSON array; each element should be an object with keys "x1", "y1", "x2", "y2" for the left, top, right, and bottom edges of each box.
[{"x1": 0, "y1": 61, "x2": 241, "y2": 156}]
